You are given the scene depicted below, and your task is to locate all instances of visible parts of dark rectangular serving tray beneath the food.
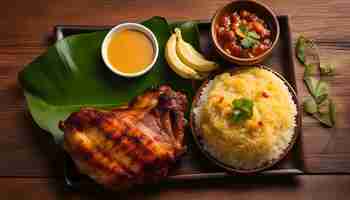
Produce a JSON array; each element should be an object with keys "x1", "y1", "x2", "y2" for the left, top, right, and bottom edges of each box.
[{"x1": 55, "y1": 16, "x2": 304, "y2": 189}]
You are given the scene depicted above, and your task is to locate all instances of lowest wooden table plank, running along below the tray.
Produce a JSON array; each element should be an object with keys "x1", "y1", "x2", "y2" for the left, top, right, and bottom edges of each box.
[{"x1": 0, "y1": 176, "x2": 350, "y2": 200}]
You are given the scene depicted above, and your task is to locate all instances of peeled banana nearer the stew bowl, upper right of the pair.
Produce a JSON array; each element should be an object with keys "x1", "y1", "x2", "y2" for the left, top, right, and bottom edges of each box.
[{"x1": 175, "y1": 28, "x2": 218, "y2": 72}]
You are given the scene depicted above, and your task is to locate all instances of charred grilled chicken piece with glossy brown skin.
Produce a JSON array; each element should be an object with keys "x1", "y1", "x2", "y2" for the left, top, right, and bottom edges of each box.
[{"x1": 59, "y1": 86, "x2": 187, "y2": 190}]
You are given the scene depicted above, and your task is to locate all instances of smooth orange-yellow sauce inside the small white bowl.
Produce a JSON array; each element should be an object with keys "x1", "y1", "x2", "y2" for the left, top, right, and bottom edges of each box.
[{"x1": 107, "y1": 29, "x2": 154, "y2": 74}]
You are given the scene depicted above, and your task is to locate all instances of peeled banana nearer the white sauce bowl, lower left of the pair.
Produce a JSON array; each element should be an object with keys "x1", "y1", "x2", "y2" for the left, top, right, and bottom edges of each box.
[{"x1": 165, "y1": 34, "x2": 206, "y2": 80}]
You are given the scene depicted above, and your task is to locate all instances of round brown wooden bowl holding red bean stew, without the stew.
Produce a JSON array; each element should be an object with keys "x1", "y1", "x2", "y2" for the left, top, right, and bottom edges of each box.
[{"x1": 211, "y1": 0, "x2": 280, "y2": 65}]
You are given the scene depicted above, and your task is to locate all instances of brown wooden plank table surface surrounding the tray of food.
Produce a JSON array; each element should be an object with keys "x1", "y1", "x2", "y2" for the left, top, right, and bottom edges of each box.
[{"x1": 0, "y1": 0, "x2": 350, "y2": 200}]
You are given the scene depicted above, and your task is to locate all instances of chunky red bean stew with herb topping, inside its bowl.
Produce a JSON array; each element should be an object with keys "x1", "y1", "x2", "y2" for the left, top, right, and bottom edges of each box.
[{"x1": 215, "y1": 9, "x2": 272, "y2": 58}]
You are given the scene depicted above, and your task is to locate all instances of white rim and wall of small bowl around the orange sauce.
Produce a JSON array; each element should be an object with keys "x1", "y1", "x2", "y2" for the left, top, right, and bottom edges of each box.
[{"x1": 101, "y1": 23, "x2": 159, "y2": 77}]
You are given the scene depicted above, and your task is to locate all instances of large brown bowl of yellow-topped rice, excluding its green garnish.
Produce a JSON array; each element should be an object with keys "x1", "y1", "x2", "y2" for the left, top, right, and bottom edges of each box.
[{"x1": 190, "y1": 66, "x2": 299, "y2": 173}]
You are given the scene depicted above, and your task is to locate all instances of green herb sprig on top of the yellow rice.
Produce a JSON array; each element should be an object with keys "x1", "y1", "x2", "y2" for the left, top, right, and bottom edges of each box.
[{"x1": 231, "y1": 98, "x2": 253, "y2": 123}]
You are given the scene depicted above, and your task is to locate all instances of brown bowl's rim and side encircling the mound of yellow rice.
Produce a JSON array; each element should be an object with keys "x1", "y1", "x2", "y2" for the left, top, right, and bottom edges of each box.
[{"x1": 190, "y1": 66, "x2": 301, "y2": 174}]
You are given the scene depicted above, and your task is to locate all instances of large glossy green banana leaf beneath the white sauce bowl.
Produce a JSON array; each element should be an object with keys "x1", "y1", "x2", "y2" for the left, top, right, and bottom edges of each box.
[{"x1": 18, "y1": 17, "x2": 199, "y2": 143}]
